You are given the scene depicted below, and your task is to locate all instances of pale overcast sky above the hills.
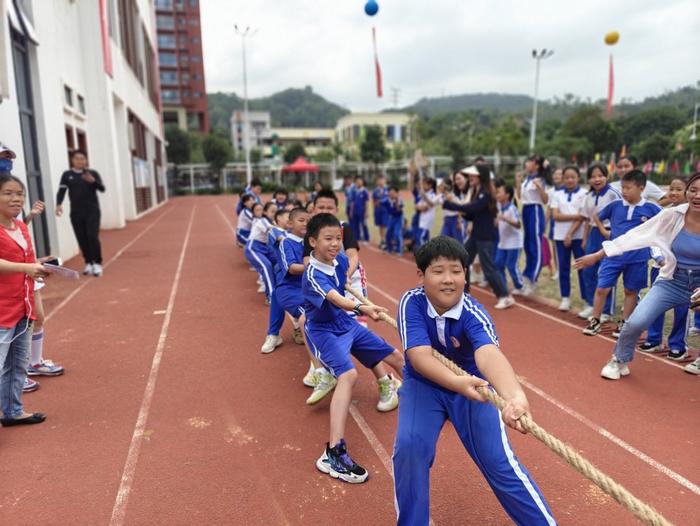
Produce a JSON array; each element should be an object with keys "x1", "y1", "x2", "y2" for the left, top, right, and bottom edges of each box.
[{"x1": 200, "y1": 0, "x2": 700, "y2": 111}]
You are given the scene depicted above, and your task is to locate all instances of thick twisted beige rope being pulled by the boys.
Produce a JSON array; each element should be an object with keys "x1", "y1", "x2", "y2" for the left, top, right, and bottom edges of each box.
[{"x1": 345, "y1": 286, "x2": 672, "y2": 526}]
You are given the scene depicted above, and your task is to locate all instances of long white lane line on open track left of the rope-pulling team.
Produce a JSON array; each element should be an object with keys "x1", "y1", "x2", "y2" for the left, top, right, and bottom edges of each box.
[{"x1": 109, "y1": 205, "x2": 197, "y2": 526}]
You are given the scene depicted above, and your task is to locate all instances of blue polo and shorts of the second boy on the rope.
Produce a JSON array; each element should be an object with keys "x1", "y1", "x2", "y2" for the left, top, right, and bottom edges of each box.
[{"x1": 301, "y1": 253, "x2": 394, "y2": 378}]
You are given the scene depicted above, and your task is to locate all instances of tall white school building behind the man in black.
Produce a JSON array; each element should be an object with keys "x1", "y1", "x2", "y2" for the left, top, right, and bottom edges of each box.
[{"x1": 0, "y1": 0, "x2": 167, "y2": 259}]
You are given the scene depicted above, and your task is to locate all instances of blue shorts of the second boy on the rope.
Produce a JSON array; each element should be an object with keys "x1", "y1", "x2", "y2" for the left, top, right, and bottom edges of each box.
[{"x1": 304, "y1": 322, "x2": 394, "y2": 378}]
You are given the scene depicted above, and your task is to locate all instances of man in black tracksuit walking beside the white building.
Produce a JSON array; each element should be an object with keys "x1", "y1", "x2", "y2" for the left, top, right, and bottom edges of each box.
[{"x1": 56, "y1": 150, "x2": 105, "y2": 277}]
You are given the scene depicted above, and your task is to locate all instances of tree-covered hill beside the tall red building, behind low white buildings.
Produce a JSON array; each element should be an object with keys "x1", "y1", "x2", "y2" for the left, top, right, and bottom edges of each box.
[{"x1": 208, "y1": 86, "x2": 349, "y2": 132}]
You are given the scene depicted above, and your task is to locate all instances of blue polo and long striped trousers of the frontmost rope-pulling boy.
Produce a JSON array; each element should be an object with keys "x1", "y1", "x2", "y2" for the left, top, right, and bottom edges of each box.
[{"x1": 393, "y1": 287, "x2": 556, "y2": 526}]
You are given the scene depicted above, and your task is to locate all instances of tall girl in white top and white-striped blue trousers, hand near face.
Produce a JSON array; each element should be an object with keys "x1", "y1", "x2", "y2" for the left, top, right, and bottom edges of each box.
[{"x1": 515, "y1": 155, "x2": 550, "y2": 296}]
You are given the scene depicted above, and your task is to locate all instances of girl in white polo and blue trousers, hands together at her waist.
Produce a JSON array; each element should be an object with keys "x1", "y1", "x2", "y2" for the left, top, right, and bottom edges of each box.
[{"x1": 549, "y1": 165, "x2": 586, "y2": 311}]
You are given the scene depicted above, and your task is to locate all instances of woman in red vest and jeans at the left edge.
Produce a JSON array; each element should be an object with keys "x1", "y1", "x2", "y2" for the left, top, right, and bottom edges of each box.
[{"x1": 0, "y1": 171, "x2": 48, "y2": 427}]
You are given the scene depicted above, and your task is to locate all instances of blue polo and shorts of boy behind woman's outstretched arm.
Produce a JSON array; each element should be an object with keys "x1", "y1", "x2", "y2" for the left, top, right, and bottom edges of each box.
[{"x1": 597, "y1": 199, "x2": 661, "y2": 291}]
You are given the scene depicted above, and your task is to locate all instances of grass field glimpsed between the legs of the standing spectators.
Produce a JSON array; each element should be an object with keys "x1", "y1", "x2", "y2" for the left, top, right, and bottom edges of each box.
[{"x1": 341, "y1": 193, "x2": 700, "y2": 349}]
